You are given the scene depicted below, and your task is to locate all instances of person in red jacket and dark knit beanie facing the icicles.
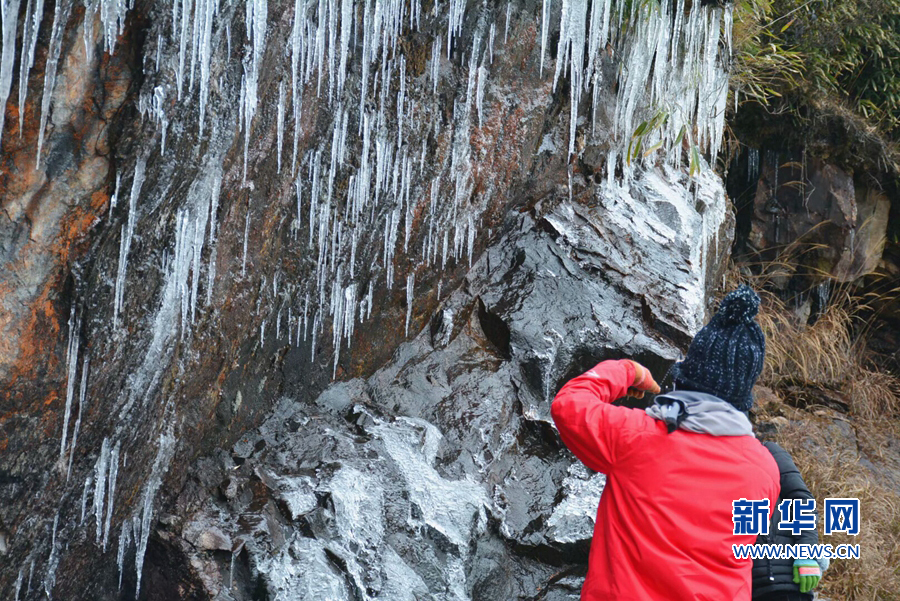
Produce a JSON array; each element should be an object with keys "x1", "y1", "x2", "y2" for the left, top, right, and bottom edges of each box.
[{"x1": 551, "y1": 286, "x2": 779, "y2": 601}]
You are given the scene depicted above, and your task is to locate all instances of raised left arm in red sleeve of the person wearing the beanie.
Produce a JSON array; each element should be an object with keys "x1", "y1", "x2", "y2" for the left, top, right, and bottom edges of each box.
[{"x1": 550, "y1": 359, "x2": 659, "y2": 472}]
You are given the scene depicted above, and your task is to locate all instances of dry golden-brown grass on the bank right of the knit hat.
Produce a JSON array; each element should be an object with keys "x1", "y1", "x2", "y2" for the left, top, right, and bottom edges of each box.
[{"x1": 729, "y1": 262, "x2": 900, "y2": 601}]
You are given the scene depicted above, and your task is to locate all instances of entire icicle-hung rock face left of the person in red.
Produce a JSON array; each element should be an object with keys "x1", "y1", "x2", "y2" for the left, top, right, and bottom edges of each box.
[{"x1": 0, "y1": 0, "x2": 732, "y2": 600}]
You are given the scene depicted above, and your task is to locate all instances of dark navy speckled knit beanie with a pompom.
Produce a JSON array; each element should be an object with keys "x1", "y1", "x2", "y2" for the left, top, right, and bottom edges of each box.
[{"x1": 671, "y1": 286, "x2": 766, "y2": 411}]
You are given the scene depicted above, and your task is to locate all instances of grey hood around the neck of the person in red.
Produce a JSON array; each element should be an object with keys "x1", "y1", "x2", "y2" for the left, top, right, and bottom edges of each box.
[{"x1": 647, "y1": 390, "x2": 753, "y2": 436}]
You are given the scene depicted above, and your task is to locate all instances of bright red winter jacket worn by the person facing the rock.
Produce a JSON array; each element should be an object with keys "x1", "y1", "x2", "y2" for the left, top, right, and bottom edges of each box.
[{"x1": 551, "y1": 361, "x2": 779, "y2": 601}]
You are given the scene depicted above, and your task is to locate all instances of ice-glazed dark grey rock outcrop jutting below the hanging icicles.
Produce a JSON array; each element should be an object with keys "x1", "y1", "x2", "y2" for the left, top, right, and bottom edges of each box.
[{"x1": 176, "y1": 177, "x2": 732, "y2": 599}]
